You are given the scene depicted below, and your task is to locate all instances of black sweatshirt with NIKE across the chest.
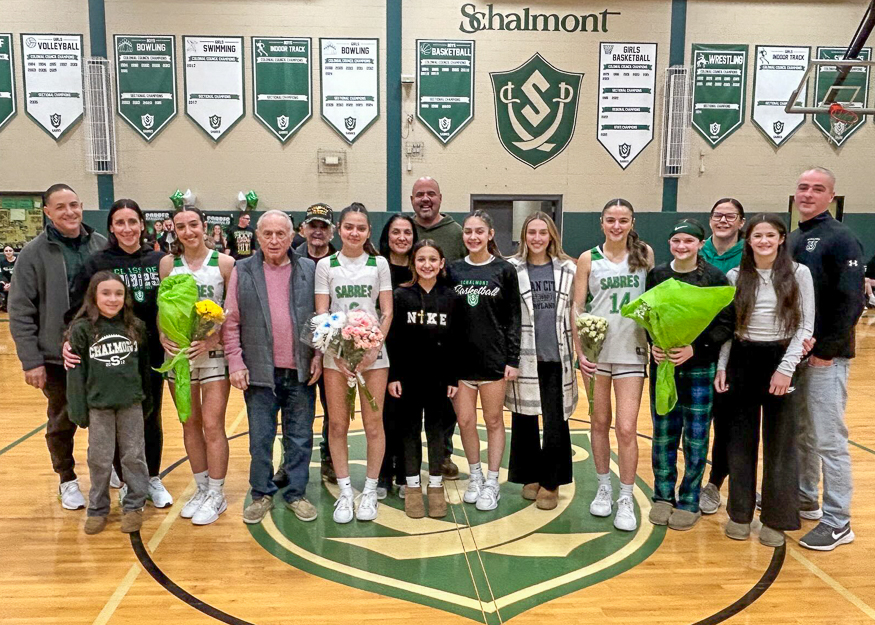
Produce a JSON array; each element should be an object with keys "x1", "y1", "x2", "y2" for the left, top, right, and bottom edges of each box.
[{"x1": 386, "y1": 283, "x2": 460, "y2": 391}]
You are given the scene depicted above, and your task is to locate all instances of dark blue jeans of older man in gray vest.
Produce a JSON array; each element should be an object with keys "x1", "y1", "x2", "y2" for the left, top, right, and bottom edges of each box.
[{"x1": 243, "y1": 369, "x2": 316, "y2": 501}]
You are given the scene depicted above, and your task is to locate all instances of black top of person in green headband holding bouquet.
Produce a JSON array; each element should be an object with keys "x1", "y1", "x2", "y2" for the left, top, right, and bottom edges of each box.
[{"x1": 644, "y1": 263, "x2": 735, "y2": 367}]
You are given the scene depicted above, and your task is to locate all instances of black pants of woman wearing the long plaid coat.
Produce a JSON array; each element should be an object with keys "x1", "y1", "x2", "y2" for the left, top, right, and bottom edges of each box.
[{"x1": 508, "y1": 362, "x2": 571, "y2": 490}]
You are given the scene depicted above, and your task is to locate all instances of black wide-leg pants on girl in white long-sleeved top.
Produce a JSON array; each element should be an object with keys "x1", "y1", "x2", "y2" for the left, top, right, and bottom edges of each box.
[{"x1": 726, "y1": 339, "x2": 800, "y2": 530}]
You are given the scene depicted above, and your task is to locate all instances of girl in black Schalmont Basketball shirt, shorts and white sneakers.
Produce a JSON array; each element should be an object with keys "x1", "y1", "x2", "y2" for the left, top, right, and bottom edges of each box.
[{"x1": 450, "y1": 210, "x2": 520, "y2": 510}]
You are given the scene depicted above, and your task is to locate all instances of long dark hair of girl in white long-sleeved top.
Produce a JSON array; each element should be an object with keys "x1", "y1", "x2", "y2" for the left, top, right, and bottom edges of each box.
[{"x1": 735, "y1": 213, "x2": 802, "y2": 336}]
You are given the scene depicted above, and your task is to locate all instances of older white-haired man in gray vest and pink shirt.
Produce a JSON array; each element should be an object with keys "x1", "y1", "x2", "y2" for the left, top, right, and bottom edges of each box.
[{"x1": 222, "y1": 210, "x2": 322, "y2": 524}]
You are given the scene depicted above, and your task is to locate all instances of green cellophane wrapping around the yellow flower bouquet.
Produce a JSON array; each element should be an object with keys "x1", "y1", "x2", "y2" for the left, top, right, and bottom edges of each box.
[{"x1": 156, "y1": 274, "x2": 198, "y2": 423}]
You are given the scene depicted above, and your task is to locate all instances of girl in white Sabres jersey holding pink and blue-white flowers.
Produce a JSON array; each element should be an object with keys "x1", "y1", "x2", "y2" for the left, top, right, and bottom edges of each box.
[{"x1": 316, "y1": 202, "x2": 392, "y2": 523}]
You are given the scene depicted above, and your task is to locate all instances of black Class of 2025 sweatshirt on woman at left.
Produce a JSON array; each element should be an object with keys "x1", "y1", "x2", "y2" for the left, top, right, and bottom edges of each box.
[{"x1": 66, "y1": 245, "x2": 165, "y2": 367}]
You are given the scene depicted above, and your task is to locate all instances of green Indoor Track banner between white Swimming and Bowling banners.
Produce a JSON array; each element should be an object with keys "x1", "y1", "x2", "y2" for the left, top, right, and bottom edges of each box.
[{"x1": 252, "y1": 37, "x2": 313, "y2": 143}]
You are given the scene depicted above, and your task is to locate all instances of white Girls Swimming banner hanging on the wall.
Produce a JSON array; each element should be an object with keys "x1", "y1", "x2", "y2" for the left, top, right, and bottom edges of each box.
[{"x1": 182, "y1": 36, "x2": 246, "y2": 141}]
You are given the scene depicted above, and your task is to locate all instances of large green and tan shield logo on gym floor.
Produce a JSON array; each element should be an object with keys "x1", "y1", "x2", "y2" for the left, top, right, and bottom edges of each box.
[{"x1": 247, "y1": 430, "x2": 665, "y2": 623}]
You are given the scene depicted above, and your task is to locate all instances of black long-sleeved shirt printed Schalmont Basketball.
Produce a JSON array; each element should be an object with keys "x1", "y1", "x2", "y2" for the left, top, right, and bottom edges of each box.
[{"x1": 449, "y1": 258, "x2": 522, "y2": 381}]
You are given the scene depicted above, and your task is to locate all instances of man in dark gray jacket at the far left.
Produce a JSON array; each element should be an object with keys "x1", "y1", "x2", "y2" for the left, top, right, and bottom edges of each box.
[{"x1": 9, "y1": 184, "x2": 106, "y2": 510}]
